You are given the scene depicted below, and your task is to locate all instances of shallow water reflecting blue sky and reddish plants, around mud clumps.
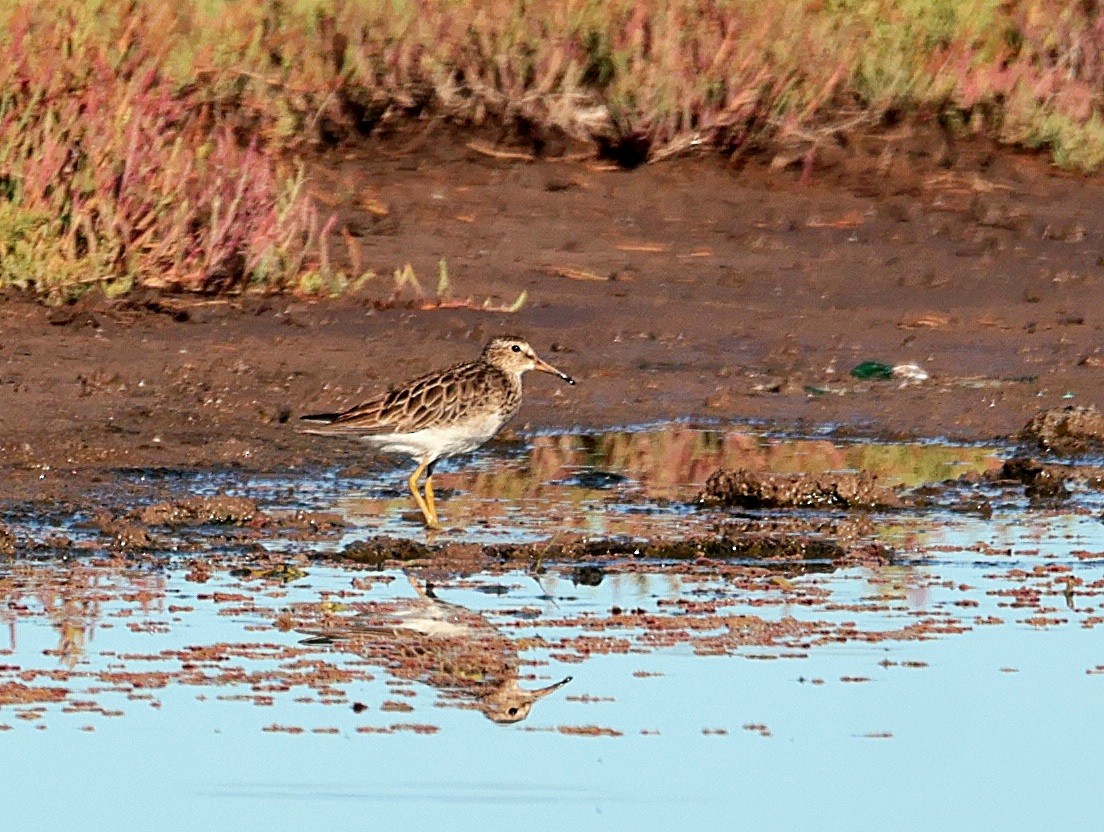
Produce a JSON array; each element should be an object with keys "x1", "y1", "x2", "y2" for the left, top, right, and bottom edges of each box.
[{"x1": 0, "y1": 427, "x2": 1104, "y2": 830}]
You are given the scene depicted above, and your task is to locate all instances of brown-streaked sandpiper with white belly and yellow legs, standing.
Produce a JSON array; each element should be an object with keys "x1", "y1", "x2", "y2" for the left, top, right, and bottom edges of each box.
[{"x1": 299, "y1": 335, "x2": 575, "y2": 529}]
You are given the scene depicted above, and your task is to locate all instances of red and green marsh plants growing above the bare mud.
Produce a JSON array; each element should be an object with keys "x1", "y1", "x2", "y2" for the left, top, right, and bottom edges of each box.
[{"x1": 0, "y1": 0, "x2": 1104, "y2": 300}]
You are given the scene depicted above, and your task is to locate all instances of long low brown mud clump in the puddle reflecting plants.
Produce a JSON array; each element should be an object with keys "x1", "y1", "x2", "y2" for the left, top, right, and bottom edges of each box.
[{"x1": 698, "y1": 468, "x2": 901, "y2": 509}]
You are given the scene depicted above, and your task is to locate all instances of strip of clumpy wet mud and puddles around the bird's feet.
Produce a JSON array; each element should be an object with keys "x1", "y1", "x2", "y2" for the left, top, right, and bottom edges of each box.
[{"x1": 0, "y1": 425, "x2": 1086, "y2": 580}]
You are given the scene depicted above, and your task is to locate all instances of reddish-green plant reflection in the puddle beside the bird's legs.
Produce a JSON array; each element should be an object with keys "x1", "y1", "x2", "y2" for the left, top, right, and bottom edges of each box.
[{"x1": 340, "y1": 425, "x2": 1000, "y2": 538}]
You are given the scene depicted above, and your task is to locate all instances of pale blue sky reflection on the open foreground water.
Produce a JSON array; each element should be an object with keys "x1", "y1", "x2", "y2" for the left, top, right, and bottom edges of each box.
[{"x1": 0, "y1": 509, "x2": 1104, "y2": 830}]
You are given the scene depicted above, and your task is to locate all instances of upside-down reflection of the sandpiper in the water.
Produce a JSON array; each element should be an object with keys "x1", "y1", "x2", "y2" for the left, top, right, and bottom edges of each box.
[{"x1": 301, "y1": 576, "x2": 571, "y2": 724}]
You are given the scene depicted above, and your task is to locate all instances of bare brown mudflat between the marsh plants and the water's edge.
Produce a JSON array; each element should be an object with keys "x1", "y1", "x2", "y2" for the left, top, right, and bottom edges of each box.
[{"x1": 0, "y1": 127, "x2": 1104, "y2": 497}]
